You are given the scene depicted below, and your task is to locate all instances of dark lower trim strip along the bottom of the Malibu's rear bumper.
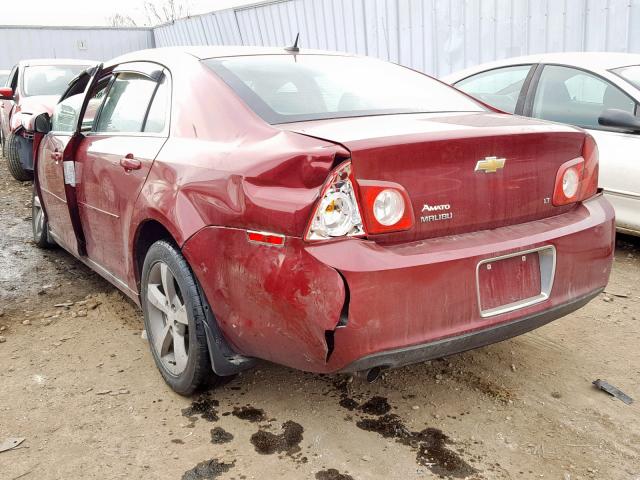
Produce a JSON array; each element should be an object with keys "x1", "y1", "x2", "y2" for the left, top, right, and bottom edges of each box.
[{"x1": 342, "y1": 288, "x2": 604, "y2": 372}]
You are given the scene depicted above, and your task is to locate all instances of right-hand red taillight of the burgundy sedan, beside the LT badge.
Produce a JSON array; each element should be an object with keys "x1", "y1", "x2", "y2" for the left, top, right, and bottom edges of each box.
[{"x1": 553, "y1": 135, "x2": 598, "y2": 206}]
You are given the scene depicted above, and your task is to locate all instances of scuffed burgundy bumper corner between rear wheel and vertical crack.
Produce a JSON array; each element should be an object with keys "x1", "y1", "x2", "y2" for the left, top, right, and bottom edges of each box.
[{"x1": 183, "y1": 227, "x2": 345, "y2": 372}]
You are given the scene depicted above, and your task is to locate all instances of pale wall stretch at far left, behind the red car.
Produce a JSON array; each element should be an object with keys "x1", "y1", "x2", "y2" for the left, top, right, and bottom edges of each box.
[{"x1": 0, "y1": 26, "x2": 155, "y2": 68}]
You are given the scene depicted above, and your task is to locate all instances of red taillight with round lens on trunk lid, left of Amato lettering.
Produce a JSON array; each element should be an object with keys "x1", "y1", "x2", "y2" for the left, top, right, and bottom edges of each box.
[{"x1": 358, "y1": 180, "x2": 413, "y2": 234}]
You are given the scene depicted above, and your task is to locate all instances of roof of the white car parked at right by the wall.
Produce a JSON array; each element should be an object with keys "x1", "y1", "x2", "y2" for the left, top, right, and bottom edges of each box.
[{"x1": 442, "y1": 52, "x2": 640, "y2": 83}]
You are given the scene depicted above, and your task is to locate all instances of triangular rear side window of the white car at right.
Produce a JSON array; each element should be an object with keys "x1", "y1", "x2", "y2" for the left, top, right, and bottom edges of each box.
[{"x1": 455, "y1": 65, "x2": 531, "y2": 113}]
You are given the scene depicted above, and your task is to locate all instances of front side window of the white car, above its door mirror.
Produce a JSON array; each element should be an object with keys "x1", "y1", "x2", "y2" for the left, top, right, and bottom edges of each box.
[{"x1": 533, "y1": 65, "x2": 635, "y2": 128}]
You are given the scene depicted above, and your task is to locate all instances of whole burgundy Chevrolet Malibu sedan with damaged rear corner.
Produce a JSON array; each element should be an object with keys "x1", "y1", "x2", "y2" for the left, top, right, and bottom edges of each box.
[{"x1": 33, "y1": 47, "x2": 614, "y2": 394}]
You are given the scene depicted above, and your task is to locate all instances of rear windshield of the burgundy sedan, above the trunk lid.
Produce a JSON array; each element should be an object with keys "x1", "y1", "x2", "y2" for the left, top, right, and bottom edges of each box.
[{"x1": 204, "y1": 55, "x2": 484, "y2": 124}]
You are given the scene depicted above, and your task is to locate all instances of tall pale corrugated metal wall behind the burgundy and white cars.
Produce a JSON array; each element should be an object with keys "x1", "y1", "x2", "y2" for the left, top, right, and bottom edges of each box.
[{"x1": 154, "y1": 0, "x2": 640, "y2": 76}]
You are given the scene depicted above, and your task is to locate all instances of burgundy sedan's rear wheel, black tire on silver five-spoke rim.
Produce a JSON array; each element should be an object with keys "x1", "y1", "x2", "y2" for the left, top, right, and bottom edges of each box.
[{"x1": 140, "y1": 240, "x2": 221, "y2": 395}]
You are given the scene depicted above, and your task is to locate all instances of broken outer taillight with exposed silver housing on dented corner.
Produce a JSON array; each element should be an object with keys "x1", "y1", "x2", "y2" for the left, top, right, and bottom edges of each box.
[{"x1": 305, "y1": 162, "x2": 365, "y2": 240}]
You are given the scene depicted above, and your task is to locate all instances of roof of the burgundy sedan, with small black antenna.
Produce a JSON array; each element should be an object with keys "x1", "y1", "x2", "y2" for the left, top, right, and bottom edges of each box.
[{"x1": 105, "y1": 46, "x2": 355, "y2": 67}]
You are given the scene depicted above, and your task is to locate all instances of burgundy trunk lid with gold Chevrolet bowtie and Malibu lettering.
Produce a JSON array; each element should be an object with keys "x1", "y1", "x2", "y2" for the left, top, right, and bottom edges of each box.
[{"x1": 280, "y1": 113, "x2": 584, "y2": 242}]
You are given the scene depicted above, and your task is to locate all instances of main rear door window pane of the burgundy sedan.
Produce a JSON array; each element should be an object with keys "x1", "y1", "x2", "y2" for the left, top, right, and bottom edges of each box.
[{"x1": 94, "y1": 73, "x2": 157, "y2": 133}]
